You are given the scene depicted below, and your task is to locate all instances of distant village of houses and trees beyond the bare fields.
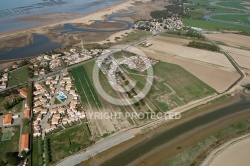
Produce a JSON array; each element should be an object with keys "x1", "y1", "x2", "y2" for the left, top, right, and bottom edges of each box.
[{"x1": 133, "y1": 14, "x2": 183, "y2": 33}]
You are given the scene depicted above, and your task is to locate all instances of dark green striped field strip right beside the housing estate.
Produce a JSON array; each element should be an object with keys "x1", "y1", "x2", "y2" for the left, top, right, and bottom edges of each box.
[{"x1": 71, "y1": 66, "x2": 102, "y2": 109}]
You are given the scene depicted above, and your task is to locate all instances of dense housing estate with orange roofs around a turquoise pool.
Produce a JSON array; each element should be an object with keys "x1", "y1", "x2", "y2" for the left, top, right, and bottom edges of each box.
[{"x1": 33, "y1": 71, "x2": 85, "y2": 136}]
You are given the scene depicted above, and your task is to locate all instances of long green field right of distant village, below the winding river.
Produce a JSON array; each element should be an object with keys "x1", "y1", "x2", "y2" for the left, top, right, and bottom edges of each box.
[{"x1": 182, "y1": 19, "x2": 250, "y2": 34}]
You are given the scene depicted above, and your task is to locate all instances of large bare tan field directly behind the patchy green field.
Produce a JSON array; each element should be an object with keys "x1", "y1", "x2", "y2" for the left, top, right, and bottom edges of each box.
[{"x1": 139, "y1": 36, "x2": 240, "y2": 93}]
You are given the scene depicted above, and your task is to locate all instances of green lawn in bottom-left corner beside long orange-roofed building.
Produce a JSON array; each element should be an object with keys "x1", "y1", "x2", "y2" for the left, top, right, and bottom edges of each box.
[{"x1": 0, "y1": 126, "x2": 20, "y2": 160}]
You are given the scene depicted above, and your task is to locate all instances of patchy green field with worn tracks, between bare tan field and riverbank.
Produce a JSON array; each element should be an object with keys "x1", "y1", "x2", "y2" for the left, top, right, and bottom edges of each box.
[{"x1": 128, "y1": 62, "x2": 215, "y2": 111}]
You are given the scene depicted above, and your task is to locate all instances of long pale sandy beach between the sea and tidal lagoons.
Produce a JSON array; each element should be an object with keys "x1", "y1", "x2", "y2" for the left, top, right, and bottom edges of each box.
[{"x1": 0, "y1": 0, "x2": 135, "y2": 38}]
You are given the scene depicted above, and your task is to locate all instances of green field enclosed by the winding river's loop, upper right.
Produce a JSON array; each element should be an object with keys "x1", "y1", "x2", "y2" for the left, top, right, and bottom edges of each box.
[{"x1": 212, "y1": 15, "x2": 250, "y2": 24}]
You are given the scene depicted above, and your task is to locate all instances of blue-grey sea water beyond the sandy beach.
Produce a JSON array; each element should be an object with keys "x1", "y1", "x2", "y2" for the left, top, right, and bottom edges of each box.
[{"x1": 0, "y1": 0, "x2": 121, "y2": 32}]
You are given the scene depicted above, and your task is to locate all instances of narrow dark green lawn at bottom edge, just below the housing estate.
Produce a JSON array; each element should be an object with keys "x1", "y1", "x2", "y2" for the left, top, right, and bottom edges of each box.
[{"x1": 32, "y1": 138, "x2": 43, "y2": 166}]
